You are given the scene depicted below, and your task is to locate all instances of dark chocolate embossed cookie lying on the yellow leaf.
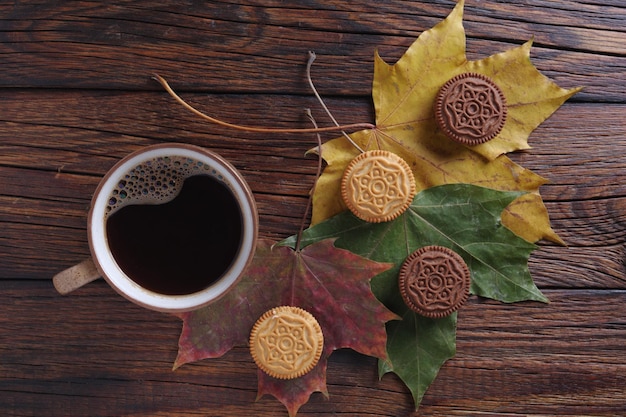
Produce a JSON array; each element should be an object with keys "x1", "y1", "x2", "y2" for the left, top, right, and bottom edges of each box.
[{"x1": 435, "y1": 73, "x2": 507, "y2": 146}]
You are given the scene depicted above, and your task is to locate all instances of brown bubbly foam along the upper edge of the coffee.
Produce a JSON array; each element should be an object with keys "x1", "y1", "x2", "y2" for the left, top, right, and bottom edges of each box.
[{"x1": 105, "y1": 156, "x2": 228, "y2": 216}]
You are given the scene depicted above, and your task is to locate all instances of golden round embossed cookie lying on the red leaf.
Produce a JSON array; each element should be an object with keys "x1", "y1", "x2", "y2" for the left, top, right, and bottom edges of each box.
[{"x1": 250, "y1": 306, "x2": 324, "y2": 379}]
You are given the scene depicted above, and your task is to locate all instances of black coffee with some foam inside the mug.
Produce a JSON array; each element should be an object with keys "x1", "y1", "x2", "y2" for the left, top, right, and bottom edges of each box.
[{"x1": 106, "y1": 174, "x2": 243, "y2": 295}]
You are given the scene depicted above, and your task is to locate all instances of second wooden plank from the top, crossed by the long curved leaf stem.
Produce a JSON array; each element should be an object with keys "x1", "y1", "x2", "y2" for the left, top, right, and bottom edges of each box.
[{"x1": 0, "y1": 91, "x2": 626, "y2": 195}]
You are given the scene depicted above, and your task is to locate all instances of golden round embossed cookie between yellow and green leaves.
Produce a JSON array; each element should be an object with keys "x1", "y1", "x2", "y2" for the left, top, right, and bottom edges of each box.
[{"x1": 341, "y1": 150, "x2": 415, "y2": 223}]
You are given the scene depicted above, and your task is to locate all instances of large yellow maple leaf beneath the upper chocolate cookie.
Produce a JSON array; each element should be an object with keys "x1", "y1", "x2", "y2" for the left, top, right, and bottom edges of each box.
[{"x1": 311, "y1": 0, "x2": 580, "y2": 243}]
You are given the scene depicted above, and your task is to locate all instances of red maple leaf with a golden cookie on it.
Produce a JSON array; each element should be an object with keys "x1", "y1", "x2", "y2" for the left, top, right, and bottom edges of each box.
[{"x1": 174, "y1": 239, "x2": 397, "y2": 416}]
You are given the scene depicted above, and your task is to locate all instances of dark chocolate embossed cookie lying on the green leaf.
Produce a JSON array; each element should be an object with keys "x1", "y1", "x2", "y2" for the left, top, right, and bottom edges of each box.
[{"x1": 398, "y1": 246, "x2": 470, "y2": 318}]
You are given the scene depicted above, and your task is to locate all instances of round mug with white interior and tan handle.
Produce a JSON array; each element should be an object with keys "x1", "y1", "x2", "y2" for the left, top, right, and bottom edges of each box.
[{"x1": 53, "y1": 144, "x2": 258, "y2": 312}]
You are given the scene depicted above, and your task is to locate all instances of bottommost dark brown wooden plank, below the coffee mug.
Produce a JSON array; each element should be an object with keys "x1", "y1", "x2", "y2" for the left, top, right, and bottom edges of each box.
[{"x1": 0, "y1": 281, "x2": 626, "y2": 417}]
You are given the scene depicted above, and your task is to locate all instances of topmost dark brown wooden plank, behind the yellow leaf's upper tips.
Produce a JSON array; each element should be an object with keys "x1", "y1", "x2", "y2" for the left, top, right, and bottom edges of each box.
[{"x1": 0, "y1": 0, "x2": 626, "y2": 103}]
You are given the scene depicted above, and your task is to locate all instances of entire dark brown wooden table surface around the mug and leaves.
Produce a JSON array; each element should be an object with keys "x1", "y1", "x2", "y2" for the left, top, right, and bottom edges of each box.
[{"x1": 0, "y1": 0, "x2": 626, "y2": 417}]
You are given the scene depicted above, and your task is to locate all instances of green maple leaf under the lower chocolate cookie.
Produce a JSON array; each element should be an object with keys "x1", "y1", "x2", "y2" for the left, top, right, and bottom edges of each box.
[{"x1": 285, "y1": 184, "x2": 548, "y2": 405}]
